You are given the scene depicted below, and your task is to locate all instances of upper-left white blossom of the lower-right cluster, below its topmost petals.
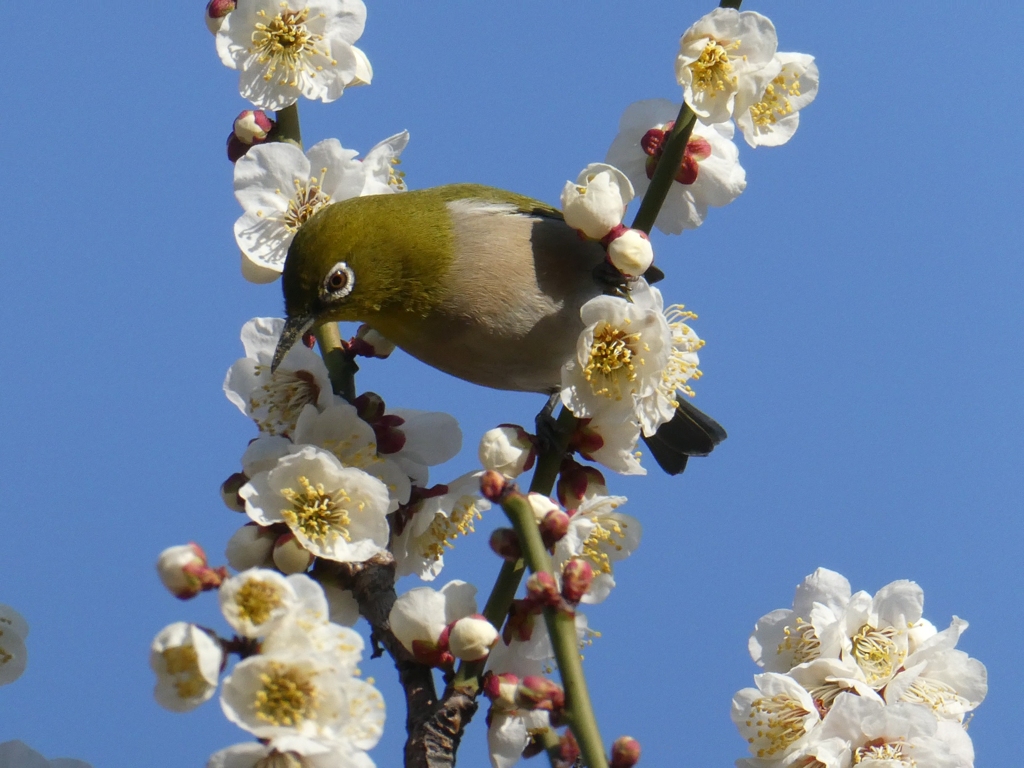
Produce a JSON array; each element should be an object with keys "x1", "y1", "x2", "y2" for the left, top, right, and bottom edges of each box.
[{"x1": 748, "y1": 568, "x2": 850, "y2": 672}]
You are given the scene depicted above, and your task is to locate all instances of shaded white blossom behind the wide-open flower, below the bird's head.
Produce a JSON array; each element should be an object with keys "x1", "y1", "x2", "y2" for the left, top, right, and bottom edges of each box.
[{"x1": 292, "y1": 397, "x2": 412, "y2": 512}]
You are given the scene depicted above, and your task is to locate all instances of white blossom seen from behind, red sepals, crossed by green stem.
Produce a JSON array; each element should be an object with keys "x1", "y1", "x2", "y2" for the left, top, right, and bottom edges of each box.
[{"x1": 605, "y1": 98, "x2": 746, "y2": 234}]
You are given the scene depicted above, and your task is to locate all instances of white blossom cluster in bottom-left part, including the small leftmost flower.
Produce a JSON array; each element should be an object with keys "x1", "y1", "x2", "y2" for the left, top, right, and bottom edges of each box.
[{"x1": 150, "y1": 568, "x2": 384, "y2": 768}]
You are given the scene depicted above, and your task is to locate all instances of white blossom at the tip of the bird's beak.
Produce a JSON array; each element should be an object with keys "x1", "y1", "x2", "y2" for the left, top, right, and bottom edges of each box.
[{"x1": 224, "y1": 317, "x2": 334, "y2": 438}]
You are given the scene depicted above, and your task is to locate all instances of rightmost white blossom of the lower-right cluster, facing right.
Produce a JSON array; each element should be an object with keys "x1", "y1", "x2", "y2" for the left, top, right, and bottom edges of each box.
[{"x1": 885, "y1": 616, "x2": 988, "y2": 722}]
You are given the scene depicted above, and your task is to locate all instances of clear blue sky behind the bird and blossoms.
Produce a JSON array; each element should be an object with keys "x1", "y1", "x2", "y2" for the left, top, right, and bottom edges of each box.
[{"x1": 0, "y1": 0, "x2": 1024, "y2": 768}]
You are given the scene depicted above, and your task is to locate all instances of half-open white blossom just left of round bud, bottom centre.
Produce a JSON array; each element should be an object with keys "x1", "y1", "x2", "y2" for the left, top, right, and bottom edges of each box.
[{"x1": 388, "y1": 581, "x2": 476, "y2": 658}]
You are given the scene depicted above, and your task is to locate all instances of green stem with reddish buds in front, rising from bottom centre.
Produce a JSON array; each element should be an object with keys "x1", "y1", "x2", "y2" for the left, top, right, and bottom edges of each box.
[{"x1": 502, "y1": 492, "x2": 608, "y2": 768}]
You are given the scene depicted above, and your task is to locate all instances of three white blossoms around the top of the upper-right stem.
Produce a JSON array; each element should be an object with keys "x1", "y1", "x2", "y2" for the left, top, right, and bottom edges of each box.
[{"x1": 605, "y1": 8, "x2": 818, "y2": 234}]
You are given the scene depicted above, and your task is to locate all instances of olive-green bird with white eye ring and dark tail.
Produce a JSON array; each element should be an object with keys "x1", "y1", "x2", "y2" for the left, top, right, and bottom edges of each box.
[{"x1": 274, "y1": 184, "x2": 726, "y2": 474}]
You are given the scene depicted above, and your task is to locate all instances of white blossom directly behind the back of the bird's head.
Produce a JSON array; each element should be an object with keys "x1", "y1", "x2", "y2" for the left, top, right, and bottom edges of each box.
[{"x1": 234, "y1": 138, "x2": 367, "y2": 283}]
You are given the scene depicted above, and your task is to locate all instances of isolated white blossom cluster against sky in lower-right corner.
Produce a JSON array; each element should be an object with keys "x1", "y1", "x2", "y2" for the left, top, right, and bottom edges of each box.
[{"x1": 732, "y1": 568, "x2": 988, "y2": 768}]
